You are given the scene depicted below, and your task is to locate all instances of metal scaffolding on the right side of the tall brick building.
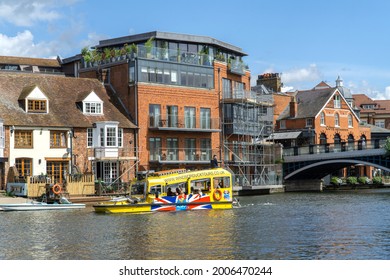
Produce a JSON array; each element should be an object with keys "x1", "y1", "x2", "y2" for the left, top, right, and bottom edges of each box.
[{"x1": 221, "y1": 86, "x2": 282, "y2": 187}]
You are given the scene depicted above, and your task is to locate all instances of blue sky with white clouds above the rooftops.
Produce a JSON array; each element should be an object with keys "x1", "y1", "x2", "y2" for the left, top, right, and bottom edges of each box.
[{"x1": 0, "y1": 0, "x2": 390, "y2": 99}]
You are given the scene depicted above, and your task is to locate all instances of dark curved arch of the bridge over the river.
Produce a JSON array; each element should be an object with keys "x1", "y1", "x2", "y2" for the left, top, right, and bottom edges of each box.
[{"x1": 284, "y1": 159, "x2": 390, "y2": 180}]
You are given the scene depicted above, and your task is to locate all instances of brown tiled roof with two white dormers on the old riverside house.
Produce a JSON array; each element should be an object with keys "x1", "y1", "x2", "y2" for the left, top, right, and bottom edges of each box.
[{"x1": 0, "y1": 72, "x2": 135, "y2": 128}]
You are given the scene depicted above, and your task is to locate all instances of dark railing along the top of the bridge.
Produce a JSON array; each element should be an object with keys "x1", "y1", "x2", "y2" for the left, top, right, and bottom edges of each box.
[{"x1": 283, "y1": 139, "x2": 386, "y2": 156}]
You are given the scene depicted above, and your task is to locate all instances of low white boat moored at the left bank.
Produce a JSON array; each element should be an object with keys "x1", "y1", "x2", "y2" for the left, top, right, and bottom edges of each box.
[{"x1": 0, "y1": 198, "x2": 85, "y2": 211}]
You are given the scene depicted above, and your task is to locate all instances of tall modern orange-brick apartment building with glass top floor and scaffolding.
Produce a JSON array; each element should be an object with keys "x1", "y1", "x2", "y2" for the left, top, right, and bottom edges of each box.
[{"x1": 63, "y1": 31, "x2": 278, "y2": 185}]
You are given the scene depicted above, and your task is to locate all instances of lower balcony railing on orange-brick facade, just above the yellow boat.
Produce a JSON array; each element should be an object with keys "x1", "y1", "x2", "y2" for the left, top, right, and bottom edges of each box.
[{"x1": 149, "y1": 148, "x2": 218, "y2": 164}]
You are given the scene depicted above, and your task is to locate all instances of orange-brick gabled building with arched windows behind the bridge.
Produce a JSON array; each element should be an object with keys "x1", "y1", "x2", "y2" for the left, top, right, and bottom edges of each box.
[{"x1": 274, "y1": 78, "x2": 370, "y2": 149}]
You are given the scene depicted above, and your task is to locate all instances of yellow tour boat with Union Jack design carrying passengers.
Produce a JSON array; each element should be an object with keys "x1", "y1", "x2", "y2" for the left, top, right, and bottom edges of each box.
[{"x1": 93, "y1": 168, "x2": 235, "y2": 213}]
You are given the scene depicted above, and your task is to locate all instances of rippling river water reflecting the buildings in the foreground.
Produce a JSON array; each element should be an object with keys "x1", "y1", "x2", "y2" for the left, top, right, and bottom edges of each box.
[{"x1": 0, "y1": 189, "x2": 390, "y2": 260}]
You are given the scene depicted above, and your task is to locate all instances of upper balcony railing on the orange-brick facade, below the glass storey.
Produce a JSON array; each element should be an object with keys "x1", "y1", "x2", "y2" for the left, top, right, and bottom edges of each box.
[{"x1": 149, "y1": 115, "x2": 220, "y2": 132}]
